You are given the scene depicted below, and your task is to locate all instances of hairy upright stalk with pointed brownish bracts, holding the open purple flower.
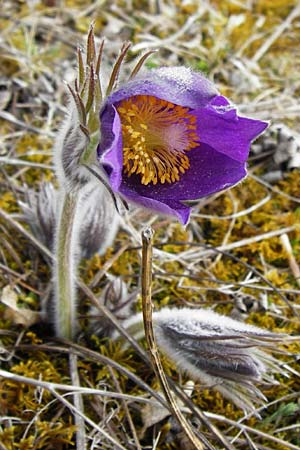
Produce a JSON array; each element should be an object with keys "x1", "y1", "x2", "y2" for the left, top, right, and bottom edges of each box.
[{"x1": 53, "y1": 26, "x2": 143, "y2": 340}]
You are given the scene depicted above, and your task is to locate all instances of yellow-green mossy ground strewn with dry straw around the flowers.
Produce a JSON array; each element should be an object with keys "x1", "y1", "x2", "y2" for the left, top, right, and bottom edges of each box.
[{"x1": 0, "y1": 0, "x2": 300, "y2": 450}]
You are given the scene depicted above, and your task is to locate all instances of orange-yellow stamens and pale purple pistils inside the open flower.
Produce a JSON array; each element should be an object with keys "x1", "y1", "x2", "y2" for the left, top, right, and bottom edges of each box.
[{"x1": 117, "y1": 95, "x2": 199, "y2": 185}]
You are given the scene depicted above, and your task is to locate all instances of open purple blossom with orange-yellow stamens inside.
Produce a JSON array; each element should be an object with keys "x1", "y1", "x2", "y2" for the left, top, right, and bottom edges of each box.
[{"x1": 98, "y1": 67, "x2": 268, "y2": 224}]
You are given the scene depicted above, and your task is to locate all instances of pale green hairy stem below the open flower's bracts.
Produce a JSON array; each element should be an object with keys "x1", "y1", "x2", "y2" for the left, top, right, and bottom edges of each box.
[{"x1": 54, "y1": 192, "x2": 79, "y2": 339}]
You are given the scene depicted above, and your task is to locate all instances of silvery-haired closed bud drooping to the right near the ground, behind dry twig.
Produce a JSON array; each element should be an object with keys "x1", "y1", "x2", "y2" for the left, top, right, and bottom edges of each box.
[{"x1": 123, "y1": 308, "x2": 285, "y2": 411}]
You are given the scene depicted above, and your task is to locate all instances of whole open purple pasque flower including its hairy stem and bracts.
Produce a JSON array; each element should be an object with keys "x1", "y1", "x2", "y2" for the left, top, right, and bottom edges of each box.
[{"x1": 49, "y1": 26, "x2": 267, "y2": 338}]
